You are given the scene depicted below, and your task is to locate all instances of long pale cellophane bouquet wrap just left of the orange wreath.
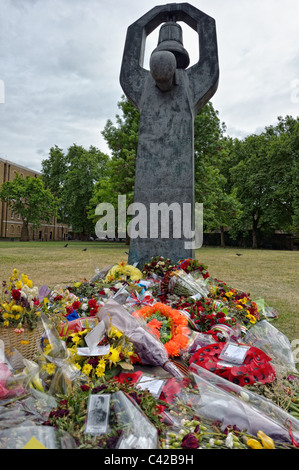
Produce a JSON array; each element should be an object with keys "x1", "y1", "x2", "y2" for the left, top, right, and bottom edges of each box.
[{"x1": 98, "y1": 300, "x2": 182, "y2": 377}]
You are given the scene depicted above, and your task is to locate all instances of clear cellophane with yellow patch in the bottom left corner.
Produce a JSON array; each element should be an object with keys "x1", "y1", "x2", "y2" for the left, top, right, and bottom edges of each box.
[{"x1": 0, "y1": 424, "x2": 76, "y2": 449}]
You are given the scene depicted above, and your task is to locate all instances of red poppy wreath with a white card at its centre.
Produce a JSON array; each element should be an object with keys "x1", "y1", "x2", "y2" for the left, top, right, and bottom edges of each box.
[{"x1": 189, "y1": 343, "x2": 275, "y2": 387}]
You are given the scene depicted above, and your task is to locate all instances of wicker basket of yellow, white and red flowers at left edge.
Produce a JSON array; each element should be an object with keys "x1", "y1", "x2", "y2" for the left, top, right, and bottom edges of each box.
[{"x1": 0, "y1": 269, "x2": 44, "y2": 358}]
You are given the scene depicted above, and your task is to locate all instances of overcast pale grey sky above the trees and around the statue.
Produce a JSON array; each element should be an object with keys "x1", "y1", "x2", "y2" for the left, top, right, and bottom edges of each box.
[{"x1": 0, "y1": 0, "x2": 299, "y2": 170}]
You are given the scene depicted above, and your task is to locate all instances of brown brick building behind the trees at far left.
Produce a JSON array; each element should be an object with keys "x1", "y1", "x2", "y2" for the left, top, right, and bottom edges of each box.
[{"x1": 0, "y1": 158, "x2": 68, "y2": 241}]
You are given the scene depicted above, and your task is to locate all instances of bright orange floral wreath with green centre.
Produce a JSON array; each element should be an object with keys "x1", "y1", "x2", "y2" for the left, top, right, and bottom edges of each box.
[{"x1": 132, "y1": 302, "x2": 190, "y2": 357}]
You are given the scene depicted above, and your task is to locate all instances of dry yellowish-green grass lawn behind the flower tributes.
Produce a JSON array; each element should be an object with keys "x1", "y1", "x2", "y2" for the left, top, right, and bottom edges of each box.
[{"x1": 0, "y1": 241, "x2": 299, "y2": 340}]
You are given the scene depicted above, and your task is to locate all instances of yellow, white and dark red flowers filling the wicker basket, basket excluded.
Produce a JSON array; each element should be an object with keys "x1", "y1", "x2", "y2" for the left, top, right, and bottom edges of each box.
[{"x1": 0, "y1": 269, "x2": 44, "y2": 334}]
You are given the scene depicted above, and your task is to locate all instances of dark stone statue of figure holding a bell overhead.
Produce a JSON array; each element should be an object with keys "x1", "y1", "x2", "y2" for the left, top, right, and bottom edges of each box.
[{"x1": 120, "y1": 3, "x2": 219, "y2": 267}]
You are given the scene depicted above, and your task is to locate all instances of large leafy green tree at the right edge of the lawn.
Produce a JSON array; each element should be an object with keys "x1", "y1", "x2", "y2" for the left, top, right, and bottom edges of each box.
[{"x1": 231, "y1": 117, "x2": 299, "y2": 248}]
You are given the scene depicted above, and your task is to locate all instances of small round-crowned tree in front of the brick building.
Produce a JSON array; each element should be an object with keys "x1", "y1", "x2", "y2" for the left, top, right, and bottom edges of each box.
[{"x1": 0, "y1": 174, "x2": 57, "y2": 241}]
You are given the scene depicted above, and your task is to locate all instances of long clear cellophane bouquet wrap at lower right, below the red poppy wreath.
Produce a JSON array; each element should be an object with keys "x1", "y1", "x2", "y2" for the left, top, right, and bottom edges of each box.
[{"x1": 189, "y1": 364, "x2": 299, "y2": 444}]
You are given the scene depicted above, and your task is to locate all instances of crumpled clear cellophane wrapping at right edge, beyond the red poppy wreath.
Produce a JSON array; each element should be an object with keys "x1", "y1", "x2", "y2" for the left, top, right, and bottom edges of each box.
[{"x1": 243, "y1": 320, "x2": 297, "y2": 373}]
